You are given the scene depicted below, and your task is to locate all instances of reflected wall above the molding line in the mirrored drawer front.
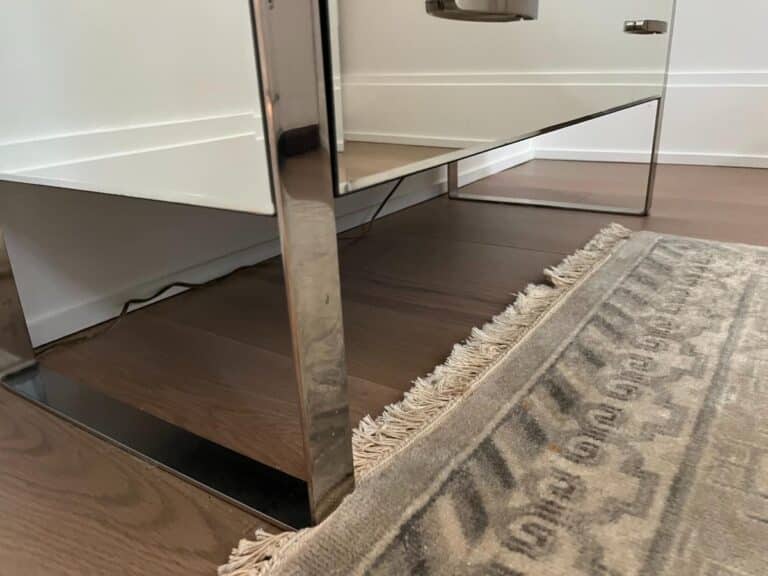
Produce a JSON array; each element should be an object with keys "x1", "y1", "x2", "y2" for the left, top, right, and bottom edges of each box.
[{"x1": 339, "y1": 0, "x2": 671, "y2": 76}]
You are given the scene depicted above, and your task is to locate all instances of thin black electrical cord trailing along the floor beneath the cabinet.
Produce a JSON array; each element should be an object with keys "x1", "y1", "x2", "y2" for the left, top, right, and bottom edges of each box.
[{"x1": 35, "y1": 176, "x2": 405, "y2": 358}]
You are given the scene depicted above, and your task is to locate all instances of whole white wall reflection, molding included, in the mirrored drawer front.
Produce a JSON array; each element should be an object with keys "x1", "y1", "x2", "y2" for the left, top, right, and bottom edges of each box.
[{"x1": 341, "y1": 0, "x2": 671, "y2": 146}]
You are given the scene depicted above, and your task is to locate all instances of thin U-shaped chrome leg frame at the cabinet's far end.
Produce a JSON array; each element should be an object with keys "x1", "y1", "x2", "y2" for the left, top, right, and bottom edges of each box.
[{"x1": 448, "y1": 97, "x2": 664, "y2": 216}]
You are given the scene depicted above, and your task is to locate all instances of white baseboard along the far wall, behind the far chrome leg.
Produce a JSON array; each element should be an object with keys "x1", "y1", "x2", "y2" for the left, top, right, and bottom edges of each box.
[{"x1": 534, "y1": 148, "x2": 768, "y2": 168}]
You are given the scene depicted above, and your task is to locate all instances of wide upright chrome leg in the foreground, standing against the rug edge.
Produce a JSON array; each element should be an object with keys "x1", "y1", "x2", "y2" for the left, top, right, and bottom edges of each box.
[{"x1": 251, "y1": 0, "x2": 354, "y2": 522}]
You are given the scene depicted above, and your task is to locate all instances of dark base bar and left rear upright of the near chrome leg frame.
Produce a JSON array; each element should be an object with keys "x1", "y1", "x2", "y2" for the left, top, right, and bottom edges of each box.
[{"x1": 0, "y1": 182, "x2": 312, "y2": 528}]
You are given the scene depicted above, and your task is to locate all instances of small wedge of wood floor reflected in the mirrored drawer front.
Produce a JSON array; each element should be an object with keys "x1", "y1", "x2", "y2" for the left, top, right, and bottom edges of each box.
[{"x1": 339, "y1": 142, "x2": 454, "y2": 182}]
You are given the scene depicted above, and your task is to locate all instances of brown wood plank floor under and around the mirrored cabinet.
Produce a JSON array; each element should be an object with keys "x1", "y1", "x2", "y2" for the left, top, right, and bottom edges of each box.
[{"x1": 0, "y1": 161, "x2": 768, "y2": 576}]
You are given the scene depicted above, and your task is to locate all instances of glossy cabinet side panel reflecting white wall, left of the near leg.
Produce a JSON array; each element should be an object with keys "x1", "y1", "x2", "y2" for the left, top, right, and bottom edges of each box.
[{"x1": 0, "y1": 0, "x2": 272, "y2": 212}]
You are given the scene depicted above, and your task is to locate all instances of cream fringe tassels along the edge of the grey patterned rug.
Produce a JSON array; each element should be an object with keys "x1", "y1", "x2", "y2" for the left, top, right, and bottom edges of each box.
[{"x1": 219, "y1": 224, "x2": 631, "y2": 576}]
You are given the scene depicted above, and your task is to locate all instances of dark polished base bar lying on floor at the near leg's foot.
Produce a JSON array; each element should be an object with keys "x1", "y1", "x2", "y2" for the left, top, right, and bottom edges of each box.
[{"x1": 3, "y1": 367, "x2": 311, "y2": 528}]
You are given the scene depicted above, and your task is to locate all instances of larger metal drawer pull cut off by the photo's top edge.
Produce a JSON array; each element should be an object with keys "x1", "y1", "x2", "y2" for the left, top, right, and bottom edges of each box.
[{"x1": 426, "y1": 0, "x2": 539, "y2": 22}]
